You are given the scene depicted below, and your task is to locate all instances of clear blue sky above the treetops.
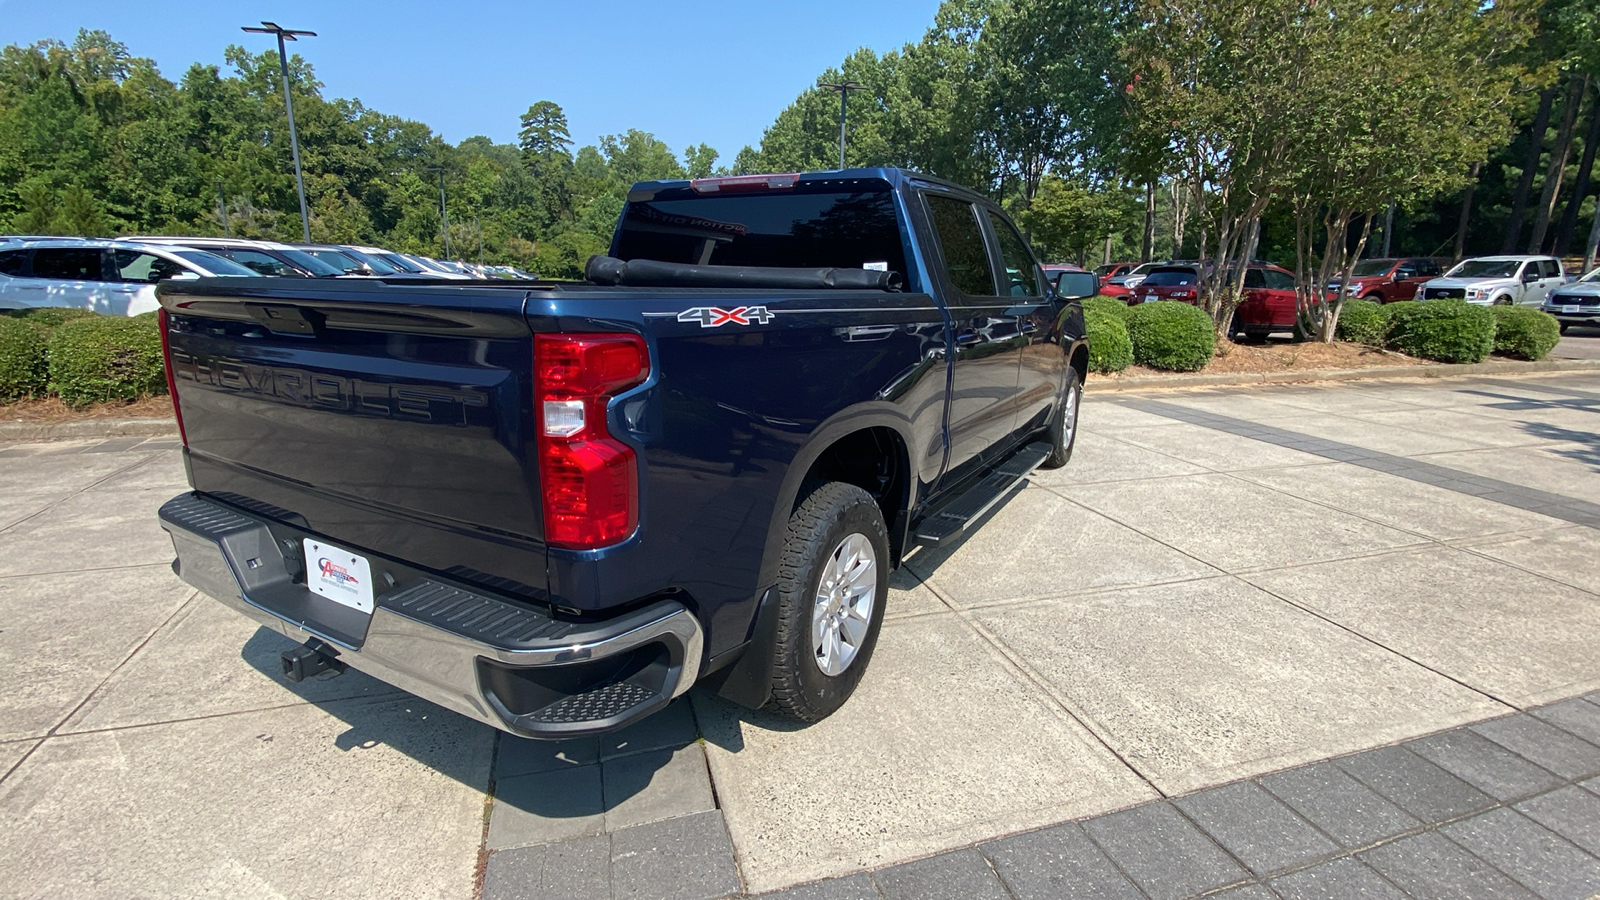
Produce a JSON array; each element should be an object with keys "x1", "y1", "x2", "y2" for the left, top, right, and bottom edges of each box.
[{"x1": 0, "y1": 0, "x2": 939, "y2": 162}]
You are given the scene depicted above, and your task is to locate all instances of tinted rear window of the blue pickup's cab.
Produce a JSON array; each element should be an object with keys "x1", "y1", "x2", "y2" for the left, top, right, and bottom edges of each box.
[{"x1": 616, "y1": 184, "x2": 908, "y2": 275}]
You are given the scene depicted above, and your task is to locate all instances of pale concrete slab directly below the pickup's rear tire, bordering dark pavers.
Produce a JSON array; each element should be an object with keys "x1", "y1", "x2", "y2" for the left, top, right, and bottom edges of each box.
[{"x1": 691, "y1": 615, "x2": 1154, "y2": 892}]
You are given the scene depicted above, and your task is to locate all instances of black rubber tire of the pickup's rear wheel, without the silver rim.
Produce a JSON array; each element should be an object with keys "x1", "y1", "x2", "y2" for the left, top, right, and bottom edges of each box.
[{"x1": 771, "y1": 482, "x2": 890, "y2": 722}]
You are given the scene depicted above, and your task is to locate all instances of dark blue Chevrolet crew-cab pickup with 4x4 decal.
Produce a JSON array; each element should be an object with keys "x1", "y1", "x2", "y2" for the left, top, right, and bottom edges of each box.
[{"x1": 160, "y1": 168, "x2": 1094, "y2": 738}]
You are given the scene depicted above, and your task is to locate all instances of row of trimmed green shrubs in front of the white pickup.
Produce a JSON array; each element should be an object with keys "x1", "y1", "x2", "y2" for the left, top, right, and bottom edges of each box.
[{"x1": 1336, "y1": 299, "x2": 1562, "y2": 362}]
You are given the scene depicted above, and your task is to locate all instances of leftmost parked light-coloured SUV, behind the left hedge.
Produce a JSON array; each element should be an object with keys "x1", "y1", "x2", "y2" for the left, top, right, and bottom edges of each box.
[{"x1": 0, "y1": 237, "x2": 256, "y2": 315}]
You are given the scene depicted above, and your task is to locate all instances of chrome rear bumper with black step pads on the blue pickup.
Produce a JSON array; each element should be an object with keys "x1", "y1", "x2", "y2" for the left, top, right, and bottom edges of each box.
[{"x1": 160, "y1": 493, "x2": 704, "y2": 738}]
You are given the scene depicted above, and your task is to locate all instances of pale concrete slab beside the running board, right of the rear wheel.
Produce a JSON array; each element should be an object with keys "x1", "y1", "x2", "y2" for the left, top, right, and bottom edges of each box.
[{"x1": 891, "y1": 482, "x2": 1218, "y2": 609}]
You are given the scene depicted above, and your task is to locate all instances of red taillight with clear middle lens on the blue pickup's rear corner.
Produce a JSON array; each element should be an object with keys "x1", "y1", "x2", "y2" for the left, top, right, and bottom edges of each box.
[{"x1": 533, "y1": 335, "x2": 650, "y2": 549}]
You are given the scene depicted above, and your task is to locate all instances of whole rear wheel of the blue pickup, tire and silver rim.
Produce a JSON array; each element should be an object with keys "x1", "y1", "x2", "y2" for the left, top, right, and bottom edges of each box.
[{"x1": 773, "y1": 482, "x2": 890, "y2": 722}]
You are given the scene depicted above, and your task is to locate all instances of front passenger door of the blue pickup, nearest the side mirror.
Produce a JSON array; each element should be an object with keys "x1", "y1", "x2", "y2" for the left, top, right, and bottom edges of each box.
[{"x1": 984, "y1": 210, "x2": 1067, "y2": 436}]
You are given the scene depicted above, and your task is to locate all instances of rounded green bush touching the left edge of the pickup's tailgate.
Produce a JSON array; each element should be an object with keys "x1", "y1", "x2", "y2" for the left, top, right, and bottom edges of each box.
[{"x1": 50, "y1": 315, "x2": 166, "y2": 407}]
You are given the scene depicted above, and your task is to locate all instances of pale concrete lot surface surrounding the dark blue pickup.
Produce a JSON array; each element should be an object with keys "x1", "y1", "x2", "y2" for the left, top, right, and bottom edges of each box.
[{"x1": 0, "y1": 373, "x2": 1600, "y2": 898}]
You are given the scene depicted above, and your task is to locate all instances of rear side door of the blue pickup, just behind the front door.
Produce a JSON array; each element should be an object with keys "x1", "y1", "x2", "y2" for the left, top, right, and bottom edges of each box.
[{"x1": 925, "y1": 192, "x2": 1021, "y2": 490}]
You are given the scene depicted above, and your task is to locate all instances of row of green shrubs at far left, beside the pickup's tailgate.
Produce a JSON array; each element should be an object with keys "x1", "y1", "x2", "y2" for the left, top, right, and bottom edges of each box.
[{"x1": 0, "y1": 309, "x2": 166, "y2": 407}]
